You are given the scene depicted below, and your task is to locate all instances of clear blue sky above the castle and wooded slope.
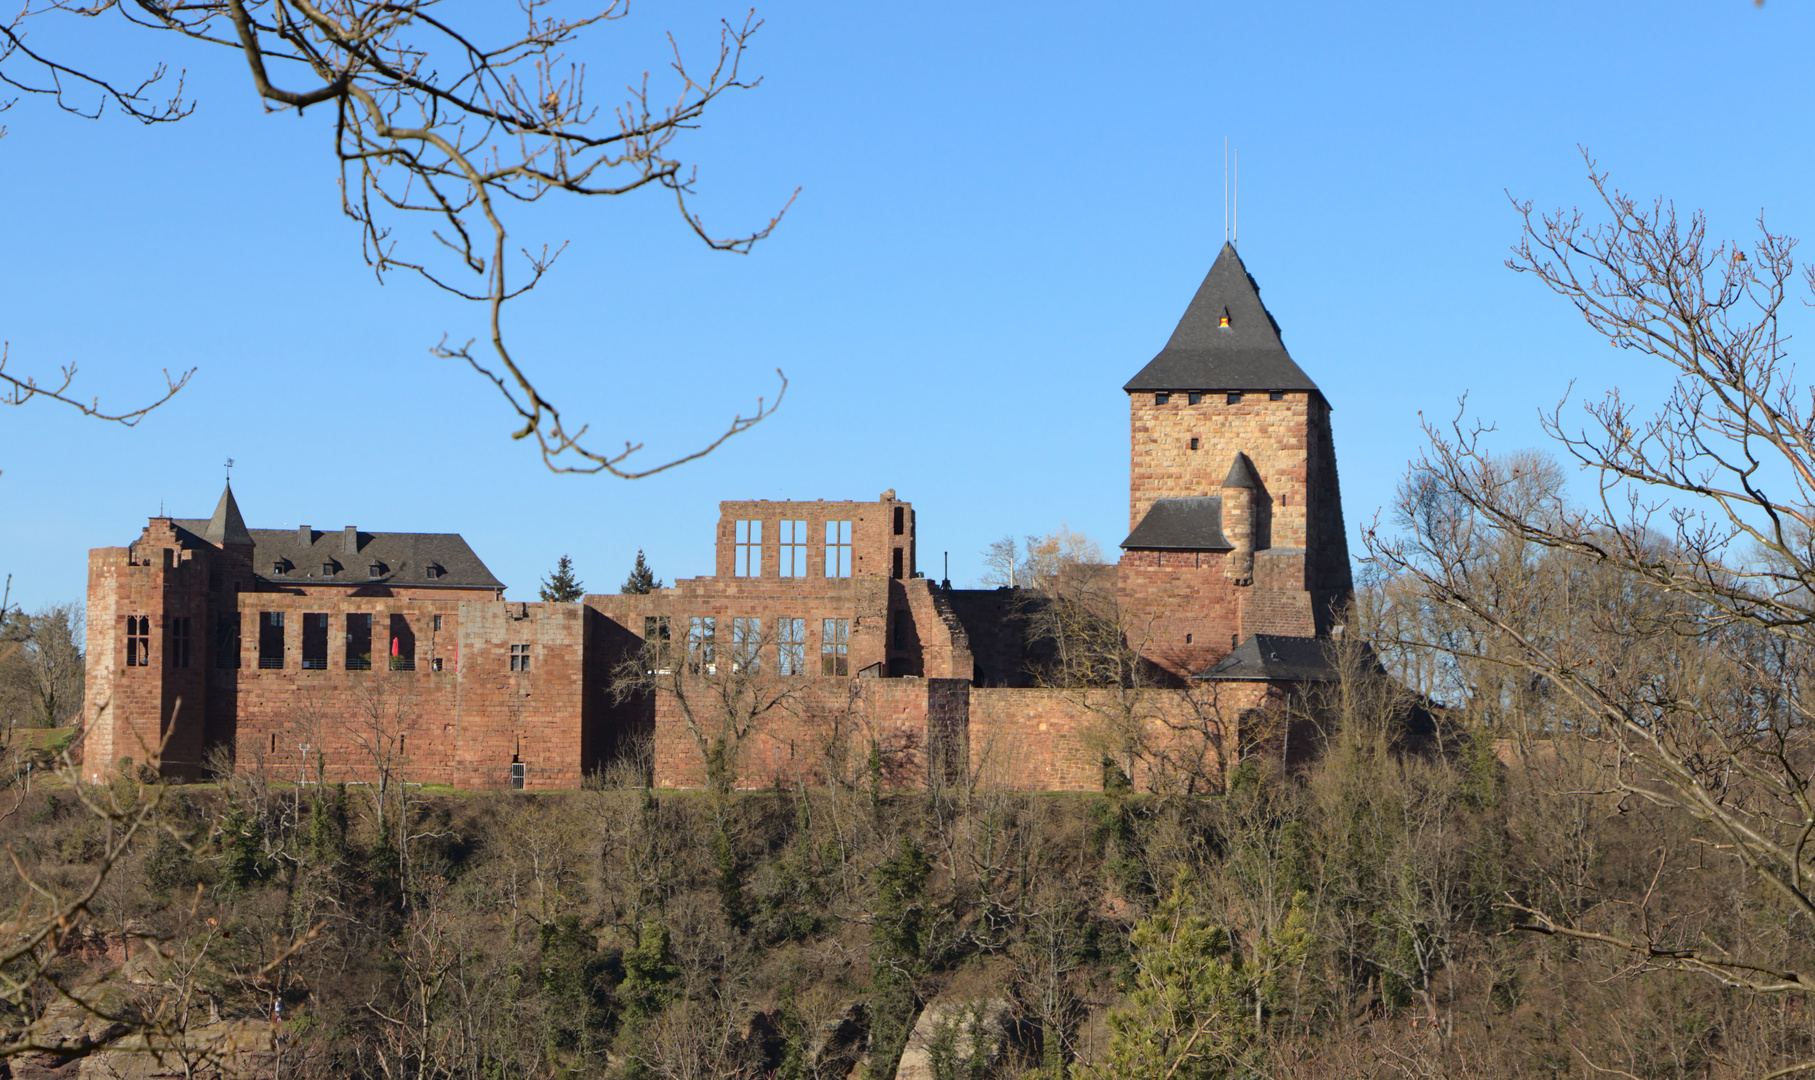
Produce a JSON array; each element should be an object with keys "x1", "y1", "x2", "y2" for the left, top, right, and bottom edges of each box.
[{"x1": 0, "y1": 0, "x2": 1815, "y2": 608}]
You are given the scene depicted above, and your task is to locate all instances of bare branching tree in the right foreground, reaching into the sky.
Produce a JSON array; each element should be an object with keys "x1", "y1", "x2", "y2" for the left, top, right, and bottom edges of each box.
[{"x1": 1369, "y1": 162, "x2": 1815, "y2": 1076}]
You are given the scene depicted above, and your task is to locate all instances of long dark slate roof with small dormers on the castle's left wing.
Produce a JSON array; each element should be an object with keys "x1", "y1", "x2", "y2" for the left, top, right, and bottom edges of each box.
[{"x1": 172, "y1": 510, "x2": 505, "y2": 588}]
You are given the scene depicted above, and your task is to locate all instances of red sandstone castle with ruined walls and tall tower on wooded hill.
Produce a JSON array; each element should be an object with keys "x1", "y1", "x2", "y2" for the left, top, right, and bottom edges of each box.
[{"x1": 82, "y1": 245, "x2": 1350, "y2": 790}]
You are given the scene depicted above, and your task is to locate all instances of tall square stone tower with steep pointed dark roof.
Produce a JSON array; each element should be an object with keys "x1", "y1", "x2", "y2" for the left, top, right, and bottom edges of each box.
[{"x1": 1118, "y1": 243, "x2": 1352, "y2": 677}]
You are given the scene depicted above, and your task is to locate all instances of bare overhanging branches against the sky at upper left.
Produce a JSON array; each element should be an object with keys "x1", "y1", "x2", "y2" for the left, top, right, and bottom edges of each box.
[{"x1": 0, "y1": 0, "x2": 793, "y2": 477}]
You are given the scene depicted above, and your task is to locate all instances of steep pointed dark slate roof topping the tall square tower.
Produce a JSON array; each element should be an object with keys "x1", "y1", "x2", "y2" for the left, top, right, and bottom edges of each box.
[{"x1": 1122, "y1": 243, "x2": 1318, "y2": 394}]
